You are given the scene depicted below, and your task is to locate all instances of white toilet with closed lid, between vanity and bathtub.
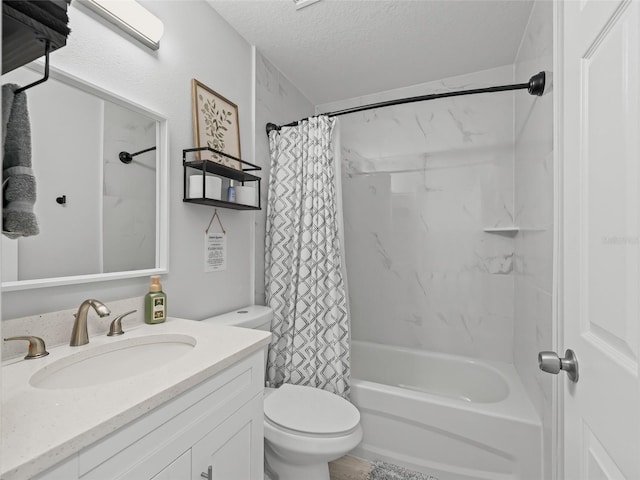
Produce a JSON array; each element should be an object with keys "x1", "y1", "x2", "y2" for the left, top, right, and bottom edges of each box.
[{"x1": 203, "y1": 305, "x2": 362, "y2": 480}]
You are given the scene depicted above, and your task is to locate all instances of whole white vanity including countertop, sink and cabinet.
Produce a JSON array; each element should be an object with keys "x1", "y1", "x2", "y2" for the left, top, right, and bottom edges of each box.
[{"x1": 1, "y1": 319, "x2": 270, "y2": 480}]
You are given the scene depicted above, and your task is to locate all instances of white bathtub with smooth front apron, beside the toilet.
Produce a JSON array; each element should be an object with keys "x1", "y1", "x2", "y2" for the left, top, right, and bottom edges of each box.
[{"x1": 351, "y1": 340, "x2": 542, "y2": 480}]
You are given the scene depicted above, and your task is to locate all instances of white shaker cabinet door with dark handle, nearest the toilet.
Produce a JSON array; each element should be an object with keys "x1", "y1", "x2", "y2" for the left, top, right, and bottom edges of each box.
[{"x1": 191, "y1": 395, "x2": 264, "y2": 480}]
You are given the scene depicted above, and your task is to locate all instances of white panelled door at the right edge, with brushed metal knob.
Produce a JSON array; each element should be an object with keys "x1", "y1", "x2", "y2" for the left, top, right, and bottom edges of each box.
[{"x1": 558, "y1": 0, "x2": 640, "y2": 480}]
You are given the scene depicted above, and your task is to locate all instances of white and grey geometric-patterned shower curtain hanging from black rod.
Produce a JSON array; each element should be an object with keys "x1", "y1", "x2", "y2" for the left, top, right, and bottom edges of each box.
[{"x1": 265, "y1": 116, "x2": 350, "y2": 398}]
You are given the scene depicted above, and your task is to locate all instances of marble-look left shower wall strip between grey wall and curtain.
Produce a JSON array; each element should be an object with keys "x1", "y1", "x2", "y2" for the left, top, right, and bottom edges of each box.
[{"x1": 255, "y1": 52, "x2": 314, "y2": 305}]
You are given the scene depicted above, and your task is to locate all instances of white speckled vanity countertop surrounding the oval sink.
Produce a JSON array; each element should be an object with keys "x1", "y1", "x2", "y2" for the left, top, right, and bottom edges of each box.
[{"x1": 0, "y1": 318, "x2": 270, "y2": 480}]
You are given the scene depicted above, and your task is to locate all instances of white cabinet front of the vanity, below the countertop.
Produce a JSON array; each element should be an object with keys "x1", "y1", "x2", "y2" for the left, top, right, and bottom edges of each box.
[{"x1": 36, "y1": 350, "x2": 264, "y2": 480}]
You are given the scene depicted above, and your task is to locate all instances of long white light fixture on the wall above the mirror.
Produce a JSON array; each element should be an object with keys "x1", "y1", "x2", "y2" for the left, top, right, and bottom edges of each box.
[{"x1": 80, "y1": 0, "x2": 164, "y2": 50}]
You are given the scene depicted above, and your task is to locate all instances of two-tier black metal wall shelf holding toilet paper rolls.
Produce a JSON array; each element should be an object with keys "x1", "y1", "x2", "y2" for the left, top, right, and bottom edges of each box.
[{"x1": 182, "y1": 147, "x2": 262, "y2": 210}]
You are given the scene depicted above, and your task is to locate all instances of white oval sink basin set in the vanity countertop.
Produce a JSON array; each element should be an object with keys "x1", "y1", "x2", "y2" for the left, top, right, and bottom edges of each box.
[{"x1": 29, "y1": 334, "x2": 196, "y2": 389}]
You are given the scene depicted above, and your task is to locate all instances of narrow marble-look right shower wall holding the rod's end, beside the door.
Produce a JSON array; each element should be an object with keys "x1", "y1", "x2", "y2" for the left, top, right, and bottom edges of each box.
[{"x1": 514, "y1": 1, "x2": 554, "y2": 478}]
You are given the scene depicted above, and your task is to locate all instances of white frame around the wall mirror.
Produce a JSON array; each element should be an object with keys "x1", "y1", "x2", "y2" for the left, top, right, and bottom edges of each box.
[{"x1": 1, "y1": 61, "x2": 169, "y2": 292}]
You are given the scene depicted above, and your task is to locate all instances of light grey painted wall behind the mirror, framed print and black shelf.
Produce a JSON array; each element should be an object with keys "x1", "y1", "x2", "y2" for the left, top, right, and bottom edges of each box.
[{"x1": 2, "y1": 0, "x2": 254, "y2": 322}]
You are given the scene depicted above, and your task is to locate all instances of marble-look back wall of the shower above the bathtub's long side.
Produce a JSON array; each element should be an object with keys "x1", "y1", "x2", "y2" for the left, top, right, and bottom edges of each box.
[{"x1": 318, "y1": 66, "x2": 526, "y2": 362}]
